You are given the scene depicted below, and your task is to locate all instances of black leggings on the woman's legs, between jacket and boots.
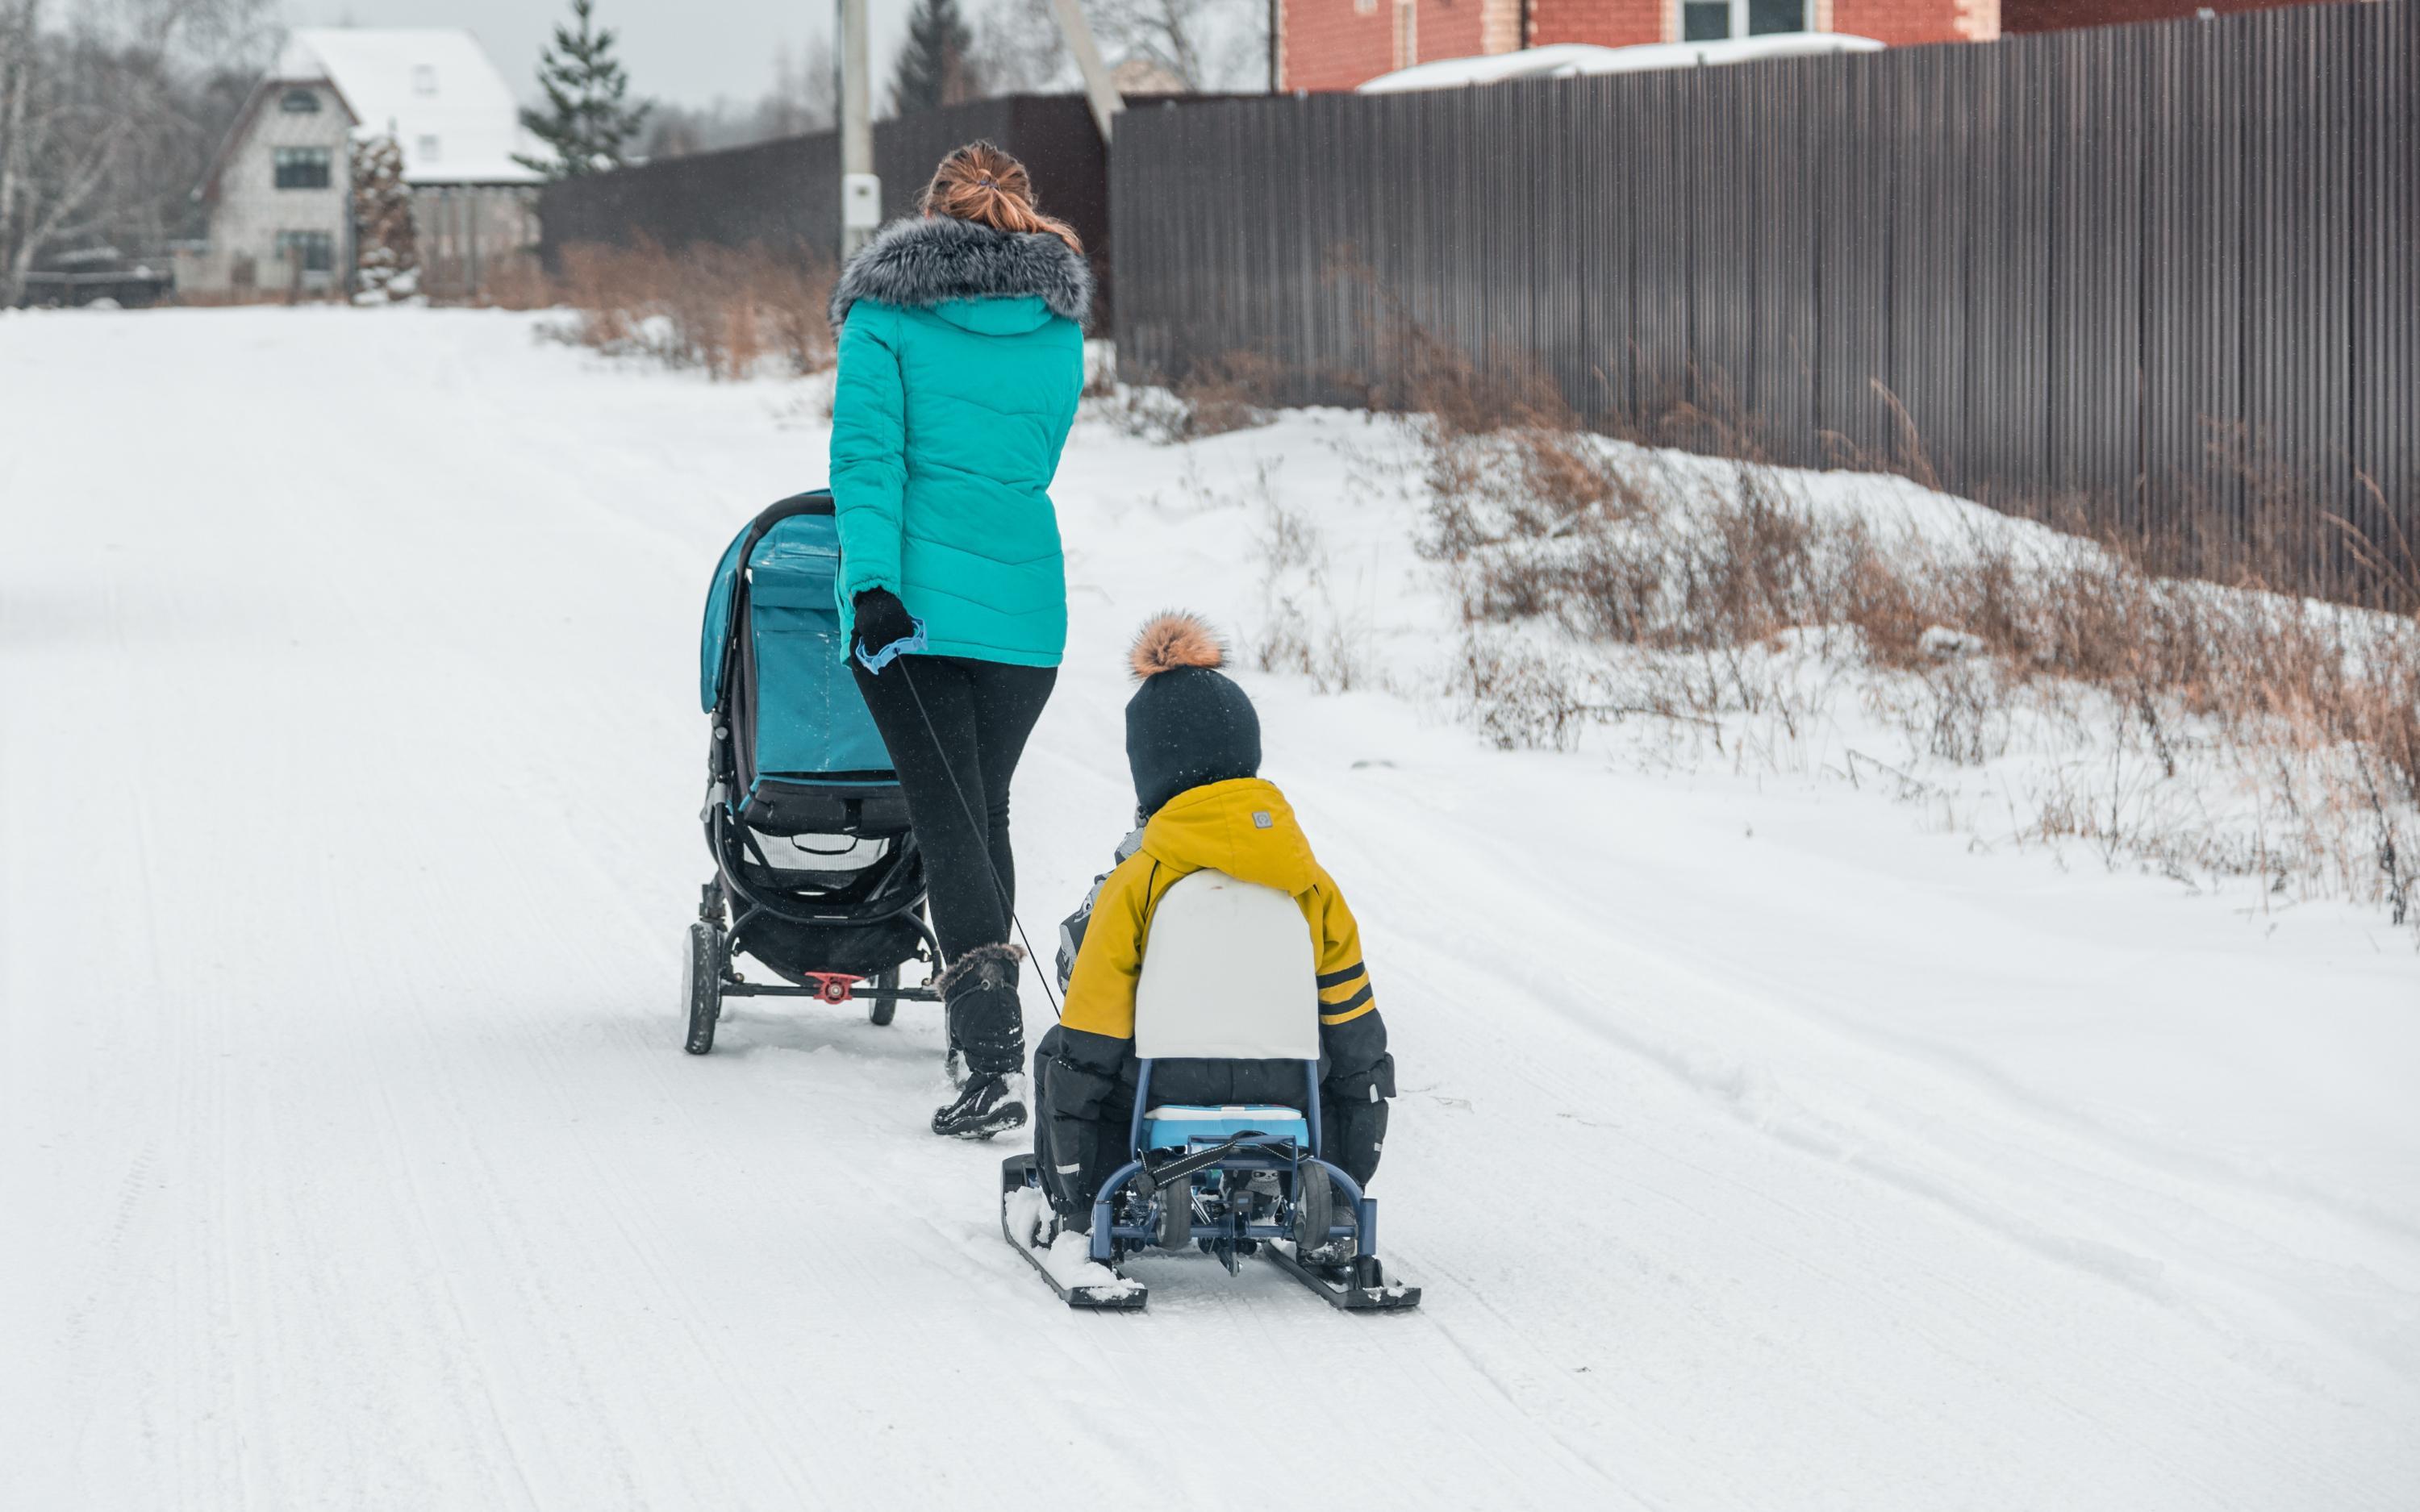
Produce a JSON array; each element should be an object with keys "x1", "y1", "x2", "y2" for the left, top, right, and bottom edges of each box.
[{"x1": 849, "y1": 656, "x2": 1058, "y2": 960}]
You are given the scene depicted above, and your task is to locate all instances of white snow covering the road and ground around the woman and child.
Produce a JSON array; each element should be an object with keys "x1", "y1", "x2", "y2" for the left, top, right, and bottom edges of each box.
[{"x1": 0, "y1": 310, "x2": 2420, "y2": 1512}]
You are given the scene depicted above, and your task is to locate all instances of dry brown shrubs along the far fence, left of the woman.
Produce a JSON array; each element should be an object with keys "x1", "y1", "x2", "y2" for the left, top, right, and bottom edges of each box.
[{"x1": 564, "y1": 240, "x2": 832, "y2": 377}]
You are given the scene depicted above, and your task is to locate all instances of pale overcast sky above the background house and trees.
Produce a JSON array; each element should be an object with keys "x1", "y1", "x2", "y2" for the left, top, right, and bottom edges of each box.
[{"x1": 286, "y1": 0, "x2": 924, "y2": 104}]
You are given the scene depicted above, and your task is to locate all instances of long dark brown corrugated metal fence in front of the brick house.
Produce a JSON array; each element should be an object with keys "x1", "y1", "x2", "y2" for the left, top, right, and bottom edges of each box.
[{"x1": 1111, "y1": 0, "x2": 2420, "y2": 598}]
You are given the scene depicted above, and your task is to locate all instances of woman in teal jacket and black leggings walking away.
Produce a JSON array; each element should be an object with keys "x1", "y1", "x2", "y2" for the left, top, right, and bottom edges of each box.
[{"x1": 832, "y1": 143, "x2": 1091, "y2": 1137}]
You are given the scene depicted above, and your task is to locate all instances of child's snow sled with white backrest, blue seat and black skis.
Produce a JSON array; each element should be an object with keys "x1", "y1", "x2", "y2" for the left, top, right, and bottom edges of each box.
[{"x1": 999, "y1": 871, "x2": 1421, "y2": 1311}]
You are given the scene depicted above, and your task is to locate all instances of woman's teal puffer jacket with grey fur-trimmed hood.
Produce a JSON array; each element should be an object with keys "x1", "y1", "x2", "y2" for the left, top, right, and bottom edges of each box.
[{"x1": 832, "y1": 215, "x2": 1091, "y2": 668}]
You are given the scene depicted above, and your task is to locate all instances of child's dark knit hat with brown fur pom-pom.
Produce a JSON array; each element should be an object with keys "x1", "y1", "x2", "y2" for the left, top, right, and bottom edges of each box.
[{"x1": 1125, "y1": 614, "x2": 1261, "y2": 815}]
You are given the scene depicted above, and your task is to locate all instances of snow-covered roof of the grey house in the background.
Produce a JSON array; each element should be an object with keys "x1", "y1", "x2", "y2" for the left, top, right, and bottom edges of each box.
[{"x1": 276, "y1": 27, "x2": 540, "y2": 184}]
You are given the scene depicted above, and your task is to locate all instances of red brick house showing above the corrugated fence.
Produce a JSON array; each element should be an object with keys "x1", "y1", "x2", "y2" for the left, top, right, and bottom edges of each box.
[{"x1": 1278, "y1": 0, "x2": 2018, "y2": 90}]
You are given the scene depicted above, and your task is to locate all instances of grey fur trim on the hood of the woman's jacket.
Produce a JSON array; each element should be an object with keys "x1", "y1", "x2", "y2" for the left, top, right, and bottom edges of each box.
[{"x1": 832, "y1": 215, "x2": 1091, "y2": 329}]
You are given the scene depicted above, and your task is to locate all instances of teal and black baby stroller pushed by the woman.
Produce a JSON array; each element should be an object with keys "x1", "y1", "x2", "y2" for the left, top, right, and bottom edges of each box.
[{"x1": 682, "y1": 489, "x2": 941, "y2": 1055}]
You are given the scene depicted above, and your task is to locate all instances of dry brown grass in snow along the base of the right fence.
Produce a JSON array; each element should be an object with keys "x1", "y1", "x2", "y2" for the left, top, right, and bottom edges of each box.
[{"x1": 1120, "y1": 303, "x2": 2420, "y2": 922}]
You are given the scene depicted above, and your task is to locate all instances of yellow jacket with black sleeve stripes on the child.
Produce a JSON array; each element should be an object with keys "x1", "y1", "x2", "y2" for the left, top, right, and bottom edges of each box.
[{"x1": 1060, "y1": 777, "x2": 1377, "y2": 1040}]
